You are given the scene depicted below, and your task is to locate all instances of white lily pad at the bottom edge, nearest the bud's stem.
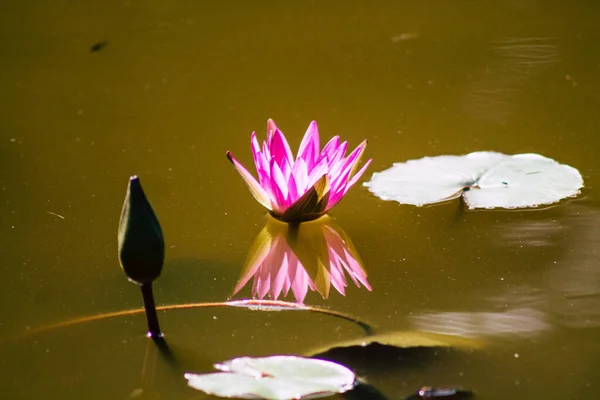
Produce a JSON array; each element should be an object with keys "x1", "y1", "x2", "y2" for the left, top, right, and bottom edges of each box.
[{"x1": 185, "y1": 355, "x2": 356, "y2": 400}]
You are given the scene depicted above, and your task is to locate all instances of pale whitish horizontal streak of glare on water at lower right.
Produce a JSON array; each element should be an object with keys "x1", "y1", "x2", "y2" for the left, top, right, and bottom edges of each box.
[{"x1": 411, "y1": 308, "x2": 550, "y2": 337}]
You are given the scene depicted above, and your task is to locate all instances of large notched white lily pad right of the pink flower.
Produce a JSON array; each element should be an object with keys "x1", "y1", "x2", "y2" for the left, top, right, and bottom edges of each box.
[{"x1": 364, "y1": 151, "x2": 583, "y2": 209}]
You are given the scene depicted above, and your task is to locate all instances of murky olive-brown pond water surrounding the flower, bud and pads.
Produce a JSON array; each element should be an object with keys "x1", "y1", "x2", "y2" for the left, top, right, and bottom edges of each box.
[{"x1": 0, "y1": 0, "x2": 600, "y2": 400}]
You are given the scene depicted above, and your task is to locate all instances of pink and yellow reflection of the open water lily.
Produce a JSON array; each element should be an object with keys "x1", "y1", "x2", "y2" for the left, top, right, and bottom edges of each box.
[{"x1": 233, "y1": 216, "x2": 371, "y2": 303}]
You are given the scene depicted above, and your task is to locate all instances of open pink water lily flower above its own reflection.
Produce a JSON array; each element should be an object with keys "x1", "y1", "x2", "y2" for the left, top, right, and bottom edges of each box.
[{"x1": 227, "y1": 119, "x2": 371, "y2": 222}]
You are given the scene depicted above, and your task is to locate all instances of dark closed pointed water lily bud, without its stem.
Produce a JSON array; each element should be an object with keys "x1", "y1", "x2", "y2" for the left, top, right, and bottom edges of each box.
[{"x1": 118, "y1": 176, "x2": 165, "y2": 285}]
